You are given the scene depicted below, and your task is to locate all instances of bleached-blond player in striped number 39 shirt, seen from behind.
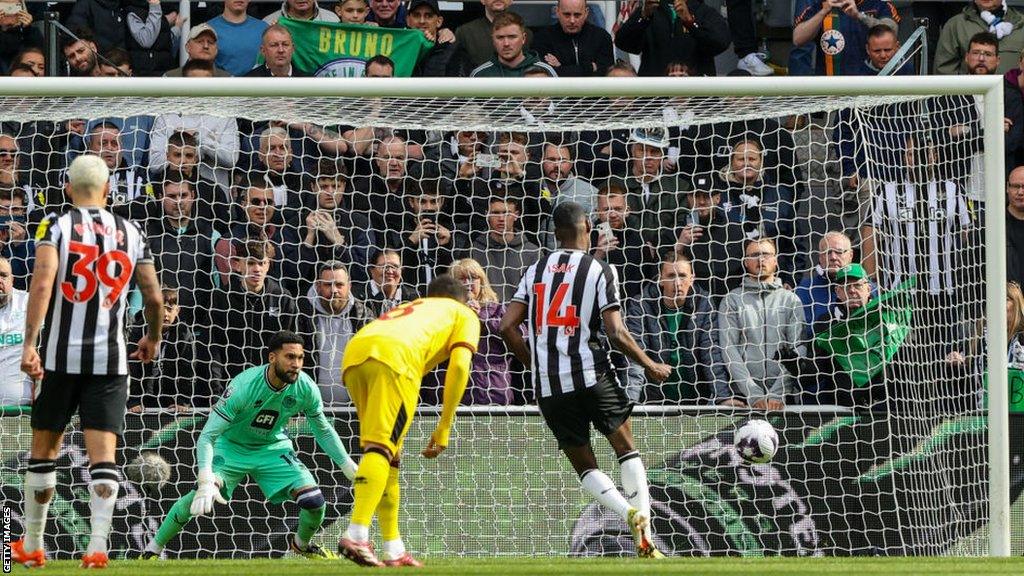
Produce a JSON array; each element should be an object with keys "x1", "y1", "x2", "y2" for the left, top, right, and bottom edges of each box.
[{"x1": 11, "y1": 155, "x2": 164, "y2": 568}]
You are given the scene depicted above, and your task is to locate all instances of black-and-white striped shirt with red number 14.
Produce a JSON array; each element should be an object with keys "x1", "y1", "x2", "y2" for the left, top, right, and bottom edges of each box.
[{"x1": 512, "y1": 250, "x2": 620, "y2": 398}]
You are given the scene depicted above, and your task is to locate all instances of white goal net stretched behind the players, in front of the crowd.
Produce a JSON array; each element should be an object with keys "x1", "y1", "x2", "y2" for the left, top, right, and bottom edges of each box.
[{"x1": 0, "y1": 79, "x2": 1011, "y2": 558}]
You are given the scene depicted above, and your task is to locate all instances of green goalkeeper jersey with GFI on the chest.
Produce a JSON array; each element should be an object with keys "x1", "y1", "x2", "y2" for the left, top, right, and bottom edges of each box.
[{"x1": 213, "y1": 364, "x2": 324, "y2": 447}]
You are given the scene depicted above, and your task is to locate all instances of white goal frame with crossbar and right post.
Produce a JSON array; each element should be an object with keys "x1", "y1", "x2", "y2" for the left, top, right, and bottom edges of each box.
[{"x1": 0, "y1": 76, "x2": 1011, "y2": 557}]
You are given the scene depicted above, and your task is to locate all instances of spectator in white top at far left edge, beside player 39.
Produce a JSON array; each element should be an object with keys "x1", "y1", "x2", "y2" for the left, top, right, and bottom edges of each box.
[{"x1": 0, "y1": 257, "x2": 33, "y2": 406}]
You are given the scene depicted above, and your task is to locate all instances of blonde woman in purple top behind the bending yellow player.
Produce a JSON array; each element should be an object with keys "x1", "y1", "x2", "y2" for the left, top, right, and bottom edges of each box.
[{"x1": 449, "y1": 258, "x2": 521, "y2": 406}]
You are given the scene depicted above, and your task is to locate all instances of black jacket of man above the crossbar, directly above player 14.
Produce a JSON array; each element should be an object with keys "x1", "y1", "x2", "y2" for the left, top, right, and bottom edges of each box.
[{"x1": 531, "y1": 23, "x2": 615, "y2": 77}]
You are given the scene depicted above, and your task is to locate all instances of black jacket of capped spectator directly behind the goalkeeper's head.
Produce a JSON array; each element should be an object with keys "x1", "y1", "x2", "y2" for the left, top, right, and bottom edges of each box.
[{"x1": 210, "y1": 277, "x2": 296, "y2": 389}]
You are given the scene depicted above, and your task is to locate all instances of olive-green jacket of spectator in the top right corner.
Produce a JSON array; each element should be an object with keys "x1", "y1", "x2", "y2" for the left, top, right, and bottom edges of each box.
[{"x1": 935, "y1": 2, "x2": 1024, "y2": 75}]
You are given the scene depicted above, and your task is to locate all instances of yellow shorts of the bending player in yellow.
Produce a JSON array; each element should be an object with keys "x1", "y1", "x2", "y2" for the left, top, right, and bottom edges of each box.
[{"x1": 343, "y1": 358, "x2": 420, "y2": 456}]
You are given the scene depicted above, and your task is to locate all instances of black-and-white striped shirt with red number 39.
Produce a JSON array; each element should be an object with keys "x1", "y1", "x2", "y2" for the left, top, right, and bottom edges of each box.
[{"x1": 36, "y1": 208, "x2": 153, "y2": 375}]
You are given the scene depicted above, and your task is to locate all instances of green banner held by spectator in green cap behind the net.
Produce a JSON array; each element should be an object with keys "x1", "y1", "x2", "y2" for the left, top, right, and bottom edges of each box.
[{"x1": 815, "y1": 278, "x2": 914, "y2": 386}]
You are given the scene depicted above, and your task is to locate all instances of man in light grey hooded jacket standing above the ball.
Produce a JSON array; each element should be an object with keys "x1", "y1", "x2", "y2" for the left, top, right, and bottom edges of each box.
[{"x1": 719, "y1": 238, "x2": 804, "y2": 410}]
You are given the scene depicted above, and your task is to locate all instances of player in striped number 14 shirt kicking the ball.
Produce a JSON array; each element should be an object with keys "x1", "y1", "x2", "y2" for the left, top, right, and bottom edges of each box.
[{"x1": 501, "y1": 202, "x2": 671, "y2": 558}]
